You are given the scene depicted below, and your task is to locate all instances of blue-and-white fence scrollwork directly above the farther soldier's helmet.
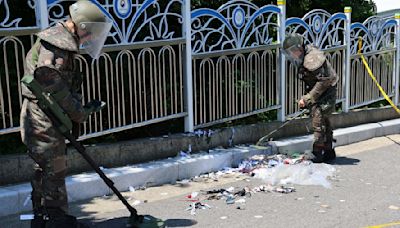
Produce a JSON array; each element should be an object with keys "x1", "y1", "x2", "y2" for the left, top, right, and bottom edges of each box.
[{"x1": 286, "y1": 9, "x2": 346, "y2": 49}]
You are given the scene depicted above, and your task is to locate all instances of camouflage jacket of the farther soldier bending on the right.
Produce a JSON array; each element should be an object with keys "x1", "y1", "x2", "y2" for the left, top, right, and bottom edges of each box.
[{"x1": 299, "y1": 45, "x2": 338, "y2": 107}]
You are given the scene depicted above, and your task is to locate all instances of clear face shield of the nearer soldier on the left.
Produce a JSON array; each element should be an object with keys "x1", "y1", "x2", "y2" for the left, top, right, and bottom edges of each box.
[{"x1": 77, "y1": 20, "x2": 112, "y2": 59}]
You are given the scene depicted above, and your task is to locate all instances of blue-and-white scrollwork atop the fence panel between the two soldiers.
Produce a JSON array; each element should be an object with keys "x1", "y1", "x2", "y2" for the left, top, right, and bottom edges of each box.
[{"x1": 191, "y1": 0, "x2": 280, "y2": 53}]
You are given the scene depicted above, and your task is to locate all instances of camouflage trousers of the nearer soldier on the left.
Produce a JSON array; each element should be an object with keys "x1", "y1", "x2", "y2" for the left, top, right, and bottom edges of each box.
[{"x1": 21, "y1": 99, "x2": 68, "y2": 213}]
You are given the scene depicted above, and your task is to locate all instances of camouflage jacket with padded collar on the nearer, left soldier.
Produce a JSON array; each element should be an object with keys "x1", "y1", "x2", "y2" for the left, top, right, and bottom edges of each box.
[{"x1": 22, "y1": 23, "x2": 87, "y2": 123}]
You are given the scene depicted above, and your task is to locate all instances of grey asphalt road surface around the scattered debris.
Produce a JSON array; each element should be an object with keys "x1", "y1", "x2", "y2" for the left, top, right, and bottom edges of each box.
[{"x1": 0, "y1": 135, "x2": 400, "y2": 228}]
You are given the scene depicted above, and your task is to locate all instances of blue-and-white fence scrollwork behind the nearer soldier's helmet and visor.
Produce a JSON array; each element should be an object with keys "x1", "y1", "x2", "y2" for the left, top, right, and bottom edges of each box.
[{"x1": 48, "y1": 0, "x2": 183, "y2": 45}]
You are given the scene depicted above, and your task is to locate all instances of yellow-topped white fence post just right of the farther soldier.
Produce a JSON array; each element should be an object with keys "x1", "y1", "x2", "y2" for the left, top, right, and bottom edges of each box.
[{"x1": 342, "y1": 7, "x2": 351, "y2": 112}]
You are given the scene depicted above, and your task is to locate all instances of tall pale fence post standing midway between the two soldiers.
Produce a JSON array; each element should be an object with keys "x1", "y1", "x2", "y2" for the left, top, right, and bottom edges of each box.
[{"x1": 183, "y1": 0, "x2": 194, "y2": 132}]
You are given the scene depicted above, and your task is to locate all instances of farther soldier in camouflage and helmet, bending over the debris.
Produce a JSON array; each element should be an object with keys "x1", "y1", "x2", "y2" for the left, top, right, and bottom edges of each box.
[{"x1": 283, "y1": 34, "x2": 338, "y2": 162}]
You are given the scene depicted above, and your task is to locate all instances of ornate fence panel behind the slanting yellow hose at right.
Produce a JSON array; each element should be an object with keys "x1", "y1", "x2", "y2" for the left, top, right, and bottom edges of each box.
[{"x1": 350, "y1": 17, "x2": 399, "y2": 108}]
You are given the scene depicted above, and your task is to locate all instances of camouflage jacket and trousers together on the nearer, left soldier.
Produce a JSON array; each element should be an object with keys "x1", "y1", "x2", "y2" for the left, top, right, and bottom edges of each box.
[{"x1": 21, "y1": 23, "x2": 88, "y2": 213}]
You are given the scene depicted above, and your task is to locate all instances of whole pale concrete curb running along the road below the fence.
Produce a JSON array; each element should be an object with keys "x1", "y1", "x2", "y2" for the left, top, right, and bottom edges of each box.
[{"x1": 0, "y1": 119, "x2": 400, "y2": 223}]
